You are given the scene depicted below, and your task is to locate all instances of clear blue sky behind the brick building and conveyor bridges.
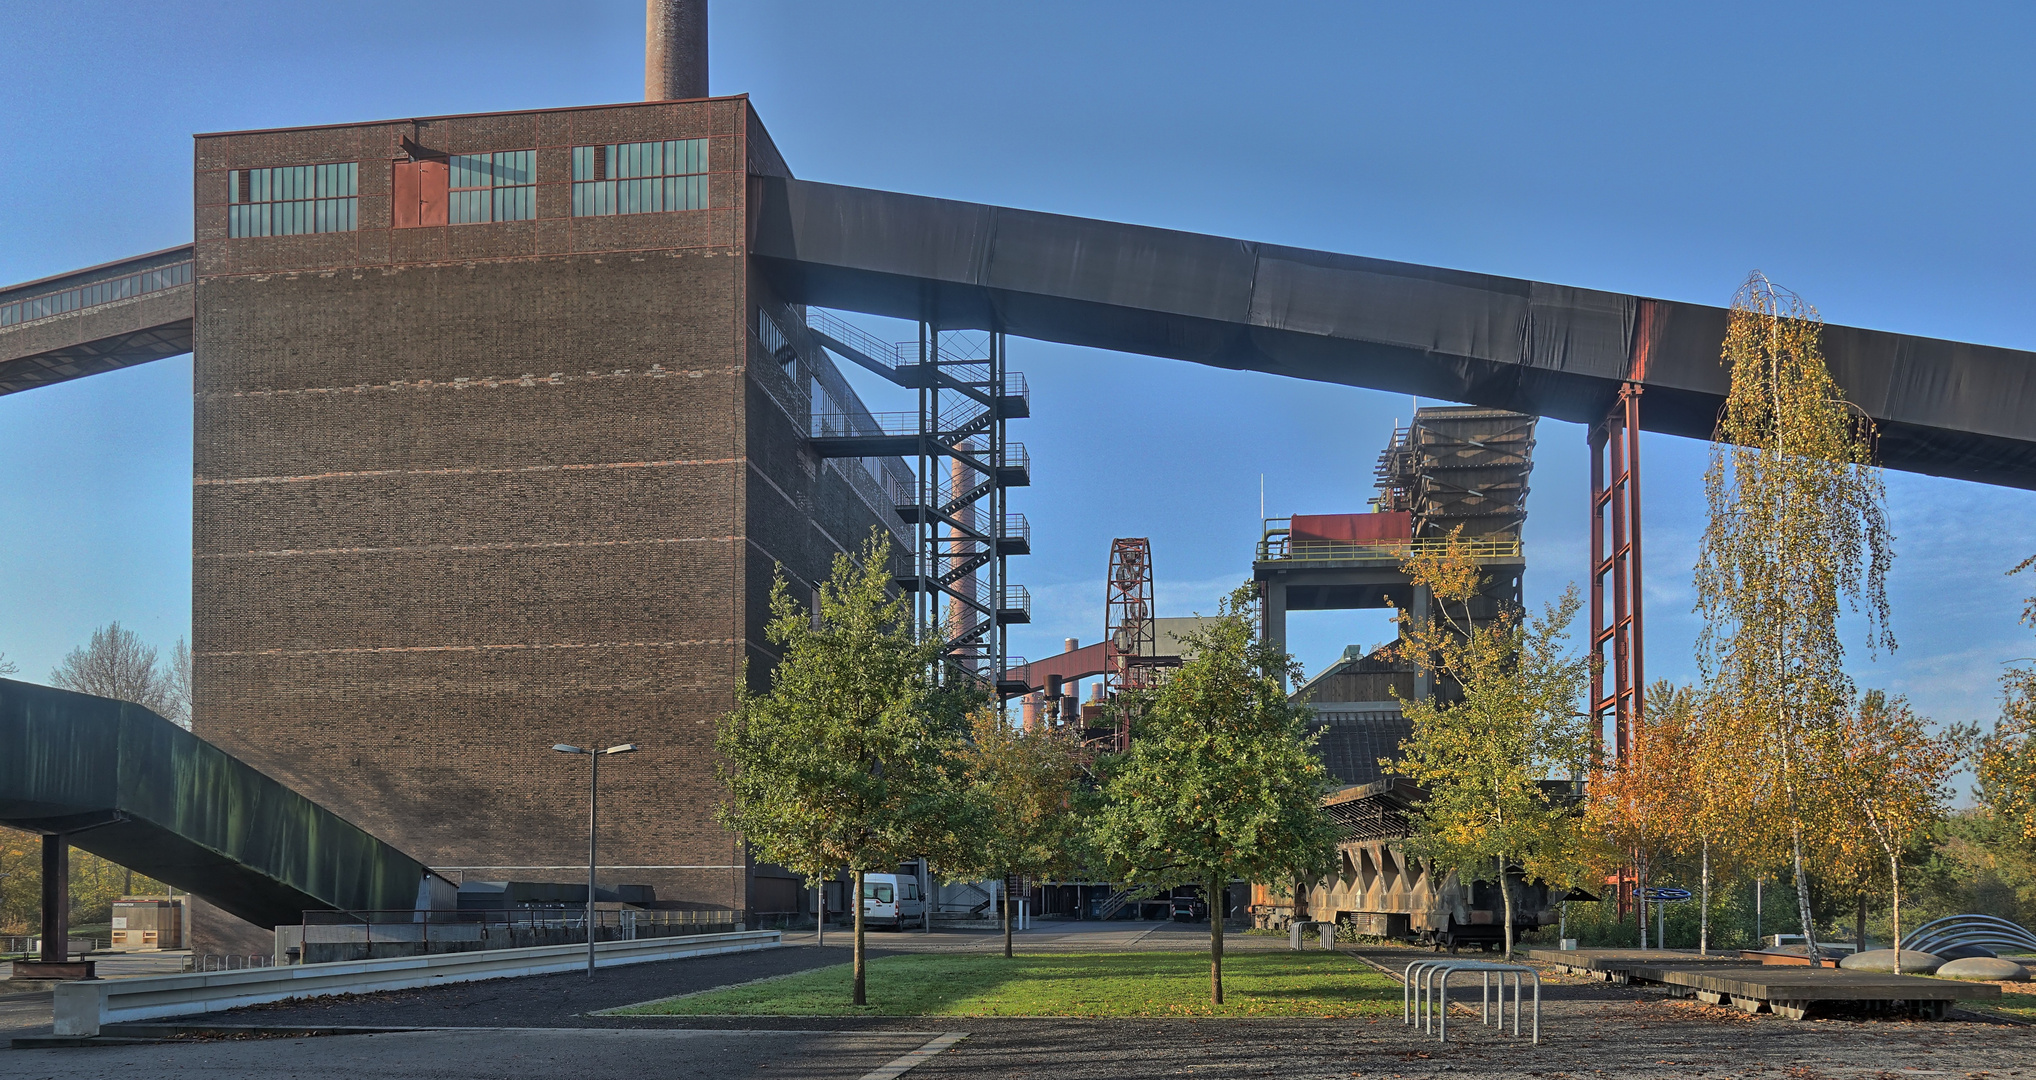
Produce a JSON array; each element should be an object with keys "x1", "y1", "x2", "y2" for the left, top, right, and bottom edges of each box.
[{"x1": 0, "y1": 0, "x2": 2036, "y2": 745}]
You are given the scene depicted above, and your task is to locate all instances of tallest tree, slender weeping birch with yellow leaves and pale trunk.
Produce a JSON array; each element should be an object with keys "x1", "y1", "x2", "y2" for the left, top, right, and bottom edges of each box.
[{"x1": 1696, "y1": 273, "x2": 1896, "y2": 958}]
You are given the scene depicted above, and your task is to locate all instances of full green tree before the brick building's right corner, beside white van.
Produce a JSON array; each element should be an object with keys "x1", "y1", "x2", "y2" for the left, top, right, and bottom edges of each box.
[{"x1": 715, "y1": 530, "x2": 981, "y2": 1005}]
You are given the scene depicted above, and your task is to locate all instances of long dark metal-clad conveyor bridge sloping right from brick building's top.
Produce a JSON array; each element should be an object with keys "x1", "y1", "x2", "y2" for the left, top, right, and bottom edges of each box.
[{"x1": 751, "y1": 177, "x2": 2036, "y2": 487}]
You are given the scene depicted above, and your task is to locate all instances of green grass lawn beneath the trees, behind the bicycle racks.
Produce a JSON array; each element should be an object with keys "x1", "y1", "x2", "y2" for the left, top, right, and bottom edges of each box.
[{"x1": 613, "y1": 952, "x2": 1401, "y2": 1017}]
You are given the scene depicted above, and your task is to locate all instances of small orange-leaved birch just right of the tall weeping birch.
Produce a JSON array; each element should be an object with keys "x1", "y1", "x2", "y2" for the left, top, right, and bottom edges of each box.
[{"x1": 1822, "y1": 691, "x2": 1977, "y2": 974}]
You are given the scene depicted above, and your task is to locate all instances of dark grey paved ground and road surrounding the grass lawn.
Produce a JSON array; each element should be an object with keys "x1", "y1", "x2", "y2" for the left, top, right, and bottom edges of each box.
[{"x1": 0, "y1": 923, "x2": 2036, "y2": 1080}]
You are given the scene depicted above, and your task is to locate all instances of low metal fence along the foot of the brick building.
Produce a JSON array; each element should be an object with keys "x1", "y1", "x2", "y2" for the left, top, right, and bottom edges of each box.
[{"x1": 299, "y1": 909, "x2": 741, "y2": 964}]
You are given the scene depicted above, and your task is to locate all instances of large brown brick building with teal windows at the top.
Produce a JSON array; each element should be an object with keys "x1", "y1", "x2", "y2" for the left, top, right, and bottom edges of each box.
[{"x1": 193, "y1": 98, "x2": 904, "y2": 952}]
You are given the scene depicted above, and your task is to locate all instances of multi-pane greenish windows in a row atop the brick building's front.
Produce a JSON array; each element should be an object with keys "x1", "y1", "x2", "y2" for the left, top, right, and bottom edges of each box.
[{"x1": 226, "y1": 139, "x2": 709, "y2": 236}]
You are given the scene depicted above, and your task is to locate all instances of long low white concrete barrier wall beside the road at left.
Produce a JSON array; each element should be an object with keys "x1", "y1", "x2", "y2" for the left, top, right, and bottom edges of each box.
[{"x1": 55, "y1": 929, "x2": 784, "y2": 1035}]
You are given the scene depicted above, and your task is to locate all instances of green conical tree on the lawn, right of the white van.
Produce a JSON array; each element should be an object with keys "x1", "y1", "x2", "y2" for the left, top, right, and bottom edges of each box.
[{"x1": 1091, "y1": 585, "x2": 1336, "y2": 1005}]
